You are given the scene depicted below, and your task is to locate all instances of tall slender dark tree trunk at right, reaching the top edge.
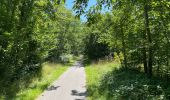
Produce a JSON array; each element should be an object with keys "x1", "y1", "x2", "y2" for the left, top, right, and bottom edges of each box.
[{"x1": 144, "y1": 0, "x2": 153, "y2": 77}]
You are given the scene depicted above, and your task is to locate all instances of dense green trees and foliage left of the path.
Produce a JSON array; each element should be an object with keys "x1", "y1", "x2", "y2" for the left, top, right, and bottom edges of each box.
[{"x1": 0, "y1": 0, "x2": 83, "y2": 99}]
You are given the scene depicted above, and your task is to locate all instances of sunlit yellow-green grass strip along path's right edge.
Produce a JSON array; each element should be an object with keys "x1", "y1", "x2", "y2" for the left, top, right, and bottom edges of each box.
[{"x1": 85, "y1": 62, "x2": 119, "y2": 100}]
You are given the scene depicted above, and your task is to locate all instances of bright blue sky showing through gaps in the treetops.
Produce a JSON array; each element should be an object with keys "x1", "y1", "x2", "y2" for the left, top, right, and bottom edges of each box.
[{"x1": 66, "y1": 0, "x2": 96, "y2": 21}]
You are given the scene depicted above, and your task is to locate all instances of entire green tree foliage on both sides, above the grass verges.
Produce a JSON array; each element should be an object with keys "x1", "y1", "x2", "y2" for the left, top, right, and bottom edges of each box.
[{"x1": 0, "y1": 0, "x2": 170, "y2": 99}]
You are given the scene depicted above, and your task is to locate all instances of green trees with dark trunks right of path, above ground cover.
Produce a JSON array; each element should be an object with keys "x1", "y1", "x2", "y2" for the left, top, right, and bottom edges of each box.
[{"x1": 74, "y1": 0, "x2": 170, "y2": 76}]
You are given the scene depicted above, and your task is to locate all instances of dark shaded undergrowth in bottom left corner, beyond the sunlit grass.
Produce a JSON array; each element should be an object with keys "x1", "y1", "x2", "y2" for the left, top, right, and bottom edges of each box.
[{"x1": 0, "y1": 66, "x2": 41, "y2": 100}]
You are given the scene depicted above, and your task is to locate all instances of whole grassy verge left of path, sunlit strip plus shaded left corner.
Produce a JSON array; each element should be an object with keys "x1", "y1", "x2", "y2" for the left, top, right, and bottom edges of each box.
[{"x1": 0, "y1": 56, "x2": 81, "y2": 100}]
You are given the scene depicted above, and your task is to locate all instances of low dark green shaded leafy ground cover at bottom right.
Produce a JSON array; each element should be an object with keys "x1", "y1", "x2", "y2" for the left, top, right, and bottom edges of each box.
[{"x1": 88, "y1": 68, "x2": 170, "y2": 100}]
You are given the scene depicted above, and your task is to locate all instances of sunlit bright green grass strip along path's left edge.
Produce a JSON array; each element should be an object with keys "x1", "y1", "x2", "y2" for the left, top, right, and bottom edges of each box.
[{"x1": 14, "y1": 63, "x2": 68, "y2": 100}]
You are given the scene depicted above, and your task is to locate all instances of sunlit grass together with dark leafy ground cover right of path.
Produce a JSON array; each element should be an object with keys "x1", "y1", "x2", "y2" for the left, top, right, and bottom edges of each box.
[{"x1": 86, "y1": 62, "x2": 170, "y2": 100}]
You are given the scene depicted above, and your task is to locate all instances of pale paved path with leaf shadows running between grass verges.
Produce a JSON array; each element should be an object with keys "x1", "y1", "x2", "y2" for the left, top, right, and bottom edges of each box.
[{"x1": 37, "y1": 62, "x2": 86, "y2": 100}]
